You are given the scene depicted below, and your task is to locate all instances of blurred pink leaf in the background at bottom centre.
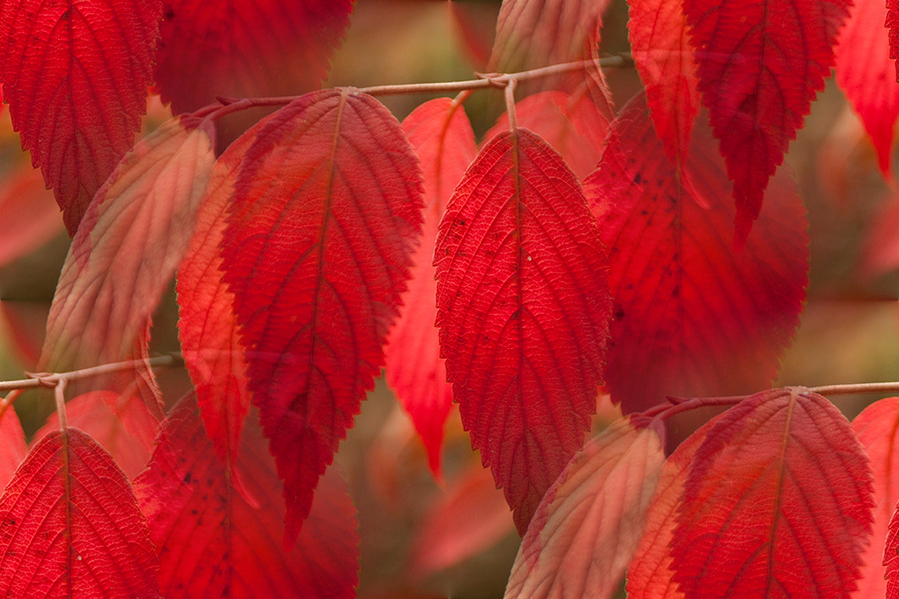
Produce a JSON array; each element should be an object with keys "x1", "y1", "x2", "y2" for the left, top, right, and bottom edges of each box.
[{"x1": 409, "y1": 465, "x2": 514, "y2": 578}]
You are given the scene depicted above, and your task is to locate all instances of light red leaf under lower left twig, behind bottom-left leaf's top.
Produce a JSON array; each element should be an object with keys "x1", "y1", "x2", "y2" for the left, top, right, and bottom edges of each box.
[{"x1": 34, "y1": 391, "x2": 159, "y2": 479}]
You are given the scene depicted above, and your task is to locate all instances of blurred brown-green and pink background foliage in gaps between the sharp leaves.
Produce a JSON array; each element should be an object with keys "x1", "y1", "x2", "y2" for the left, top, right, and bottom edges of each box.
[{"x1": 0, "y1": 0, "x2": 899, "y2": 598}]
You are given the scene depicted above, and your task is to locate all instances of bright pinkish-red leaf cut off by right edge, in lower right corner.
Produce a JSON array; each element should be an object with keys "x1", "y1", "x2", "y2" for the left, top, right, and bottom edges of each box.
[{"x1": 852, "y1": 397, "x2": 899, "y2": 599}]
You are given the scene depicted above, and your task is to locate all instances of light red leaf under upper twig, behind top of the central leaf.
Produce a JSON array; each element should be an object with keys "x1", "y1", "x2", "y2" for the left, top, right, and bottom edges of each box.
[{"x1": 484, "y1": 88, "x2": 609, "y2": 179}]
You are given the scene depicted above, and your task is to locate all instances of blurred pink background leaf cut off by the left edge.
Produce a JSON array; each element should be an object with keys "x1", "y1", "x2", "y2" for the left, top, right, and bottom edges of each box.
[{"x1": 0, "y1": 168, "x2": 62, "y2": 267}]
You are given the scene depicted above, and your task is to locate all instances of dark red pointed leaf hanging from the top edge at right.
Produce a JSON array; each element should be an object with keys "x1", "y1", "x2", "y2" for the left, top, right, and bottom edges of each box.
[{"x1": 684, "y1": 0, "x2": 851, "y2": 246}]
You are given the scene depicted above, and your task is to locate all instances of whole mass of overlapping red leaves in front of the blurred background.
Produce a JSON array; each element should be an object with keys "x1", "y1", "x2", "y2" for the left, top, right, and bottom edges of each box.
[{"x1": 0, "y1": 0, "x2": 899, "y2": 598}]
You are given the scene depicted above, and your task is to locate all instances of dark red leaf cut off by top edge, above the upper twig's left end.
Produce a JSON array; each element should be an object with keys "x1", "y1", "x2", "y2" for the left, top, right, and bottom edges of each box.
[{"x1": 156, "y1": 0, "x2": 353, "y2": 114}]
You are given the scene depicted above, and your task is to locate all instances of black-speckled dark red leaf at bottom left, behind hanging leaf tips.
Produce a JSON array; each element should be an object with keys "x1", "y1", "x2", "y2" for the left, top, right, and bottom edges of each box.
[{"x1": 135, "y1": 399, "x2": 359, "y2": 599}]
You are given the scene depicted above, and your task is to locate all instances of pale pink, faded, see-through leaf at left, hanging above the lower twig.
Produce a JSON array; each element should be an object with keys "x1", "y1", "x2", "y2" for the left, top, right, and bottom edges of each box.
[{"x1": 40, "y1": 119, "x2": 215, "y2": 408}]
